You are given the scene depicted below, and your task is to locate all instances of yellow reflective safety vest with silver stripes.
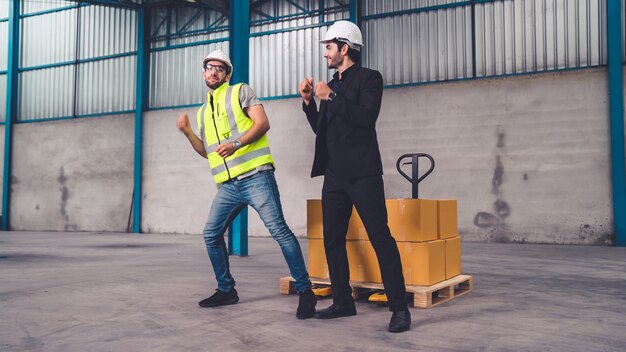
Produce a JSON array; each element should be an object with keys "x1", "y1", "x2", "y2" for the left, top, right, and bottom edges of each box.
[{"x1": 196, "y1": 83, "x2": 274, "y2": 183}]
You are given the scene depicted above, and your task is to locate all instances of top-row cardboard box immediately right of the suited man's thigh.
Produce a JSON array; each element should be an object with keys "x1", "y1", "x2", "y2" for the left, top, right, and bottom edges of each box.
[{"x1": 387, "y1": 199, "x2": 437, "y2": 242}]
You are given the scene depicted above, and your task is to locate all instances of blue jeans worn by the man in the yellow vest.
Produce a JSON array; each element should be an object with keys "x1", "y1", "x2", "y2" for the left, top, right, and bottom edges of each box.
[{"x1": 204, "y1": 170, "x2": 311, "y2": 293}]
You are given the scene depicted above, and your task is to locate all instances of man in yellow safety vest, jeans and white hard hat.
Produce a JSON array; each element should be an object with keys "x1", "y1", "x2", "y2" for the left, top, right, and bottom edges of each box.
[{"x1": 177, "y1": 50, "x2": 317, "y2": 319}]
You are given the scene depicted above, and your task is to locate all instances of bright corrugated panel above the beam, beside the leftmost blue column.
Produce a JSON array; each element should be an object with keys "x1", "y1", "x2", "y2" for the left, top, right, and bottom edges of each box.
[{"x1": 20, "y1": 9, "x2": 77, "y2": 67}]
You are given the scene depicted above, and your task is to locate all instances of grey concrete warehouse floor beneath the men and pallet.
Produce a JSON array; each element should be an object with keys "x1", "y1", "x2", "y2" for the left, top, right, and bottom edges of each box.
[{"x1": 0, "y1": 232, "x2": 626, "y2": 352}]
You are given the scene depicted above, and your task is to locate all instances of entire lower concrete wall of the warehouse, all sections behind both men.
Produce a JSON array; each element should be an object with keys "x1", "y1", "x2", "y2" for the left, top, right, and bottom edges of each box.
[{"x1": 0, "y1": 69, "x2": 613, "y2": 245}]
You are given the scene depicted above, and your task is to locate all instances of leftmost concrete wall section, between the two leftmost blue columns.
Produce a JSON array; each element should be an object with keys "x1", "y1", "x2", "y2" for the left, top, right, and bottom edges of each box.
[{"x1": 11, "y1": 115, "x2": 134, "y2": 231}]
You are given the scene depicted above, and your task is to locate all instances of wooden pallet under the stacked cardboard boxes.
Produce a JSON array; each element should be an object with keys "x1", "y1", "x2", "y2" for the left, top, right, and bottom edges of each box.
[{"x1": 280, "y1": 275, "x2": 474, "y2": 308}]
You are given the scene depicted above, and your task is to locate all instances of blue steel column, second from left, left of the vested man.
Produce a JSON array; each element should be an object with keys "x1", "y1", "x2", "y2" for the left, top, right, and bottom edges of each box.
[{"x1": 133, "y1": 8, "x2": 150, "y2": 233}]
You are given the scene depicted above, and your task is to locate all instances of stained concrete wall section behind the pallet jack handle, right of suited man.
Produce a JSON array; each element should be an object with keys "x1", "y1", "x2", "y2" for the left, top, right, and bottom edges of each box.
[{"x1": 379, "y1": 70, "x2": 613, "y2": 244}]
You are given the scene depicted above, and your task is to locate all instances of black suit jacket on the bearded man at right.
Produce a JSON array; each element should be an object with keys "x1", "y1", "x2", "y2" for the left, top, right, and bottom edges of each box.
[{"x1": 303, "y1": 64, "x2": 383, "y2": 179}]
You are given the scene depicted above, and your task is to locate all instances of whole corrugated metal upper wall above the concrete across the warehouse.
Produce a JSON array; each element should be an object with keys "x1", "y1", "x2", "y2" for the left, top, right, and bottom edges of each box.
[{"x1": 0, "y1": 0, "x2": 626, "y2": 119}]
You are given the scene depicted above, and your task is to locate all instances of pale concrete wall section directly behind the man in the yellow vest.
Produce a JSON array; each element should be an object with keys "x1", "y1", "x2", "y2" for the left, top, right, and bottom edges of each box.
[{"x1": 143, "y1": 107, "x2": 322, "y2": 236}]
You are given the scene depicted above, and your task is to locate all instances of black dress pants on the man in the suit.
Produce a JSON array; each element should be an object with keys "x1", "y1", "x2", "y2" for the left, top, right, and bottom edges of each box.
[{"x1": 322, "y1": 170, "x2": 407, "y2": 311}]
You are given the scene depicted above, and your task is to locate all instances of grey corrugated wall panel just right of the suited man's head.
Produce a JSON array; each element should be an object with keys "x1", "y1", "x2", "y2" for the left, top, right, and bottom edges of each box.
[{"x1": 363, "y1": 7, "x2": 472, "y2": 84}]
